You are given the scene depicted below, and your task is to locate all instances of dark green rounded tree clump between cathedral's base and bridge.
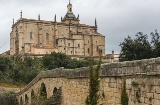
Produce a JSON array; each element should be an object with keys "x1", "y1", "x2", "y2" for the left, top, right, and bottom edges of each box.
[{"x1": 42, "y1": 52, "x2": 97, "y2": 70}]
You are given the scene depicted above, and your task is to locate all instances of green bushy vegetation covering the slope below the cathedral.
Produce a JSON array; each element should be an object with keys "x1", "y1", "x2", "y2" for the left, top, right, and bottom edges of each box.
[{"x1": 0, "y1": 52, "x2": 96, "y2": 85}]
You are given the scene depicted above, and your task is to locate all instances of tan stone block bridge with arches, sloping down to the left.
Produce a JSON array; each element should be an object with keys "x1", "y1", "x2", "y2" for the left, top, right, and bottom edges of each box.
[{"x1": 17, "y1": 58, "x2": 160, "y2": 105}]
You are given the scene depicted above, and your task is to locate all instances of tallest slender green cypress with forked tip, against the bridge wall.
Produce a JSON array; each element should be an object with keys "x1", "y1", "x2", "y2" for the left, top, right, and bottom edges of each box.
[{"x1": 85, "y1": 58, "x2": 101, "y2": 105}]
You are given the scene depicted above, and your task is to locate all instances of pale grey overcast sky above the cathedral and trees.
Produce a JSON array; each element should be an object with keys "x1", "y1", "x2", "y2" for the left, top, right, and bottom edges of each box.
[{"x1": 0, "y1": 0, "x2": 160, "y2": 54}]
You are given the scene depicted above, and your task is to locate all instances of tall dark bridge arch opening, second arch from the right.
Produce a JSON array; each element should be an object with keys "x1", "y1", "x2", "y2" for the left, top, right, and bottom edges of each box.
[{"x1": 39, "y1": 83, "x2": 47, "y2": 101}]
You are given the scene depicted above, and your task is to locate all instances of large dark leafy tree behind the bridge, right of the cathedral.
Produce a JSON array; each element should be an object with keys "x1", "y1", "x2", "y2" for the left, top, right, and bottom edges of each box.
[{"x1": 120, "y1": 32, "x2": 153, "y2": 61}]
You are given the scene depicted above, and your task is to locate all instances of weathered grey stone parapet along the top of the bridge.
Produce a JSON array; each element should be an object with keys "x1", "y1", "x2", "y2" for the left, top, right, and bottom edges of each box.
[{"x1": 17, "y1": 58, "x2": 160, "y2": 105}]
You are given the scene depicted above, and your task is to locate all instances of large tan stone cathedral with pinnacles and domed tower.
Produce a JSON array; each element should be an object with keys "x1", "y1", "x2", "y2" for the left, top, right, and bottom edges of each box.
[{"x1": 10, "y1": 2, "x2": 105, "y2": 57}]
